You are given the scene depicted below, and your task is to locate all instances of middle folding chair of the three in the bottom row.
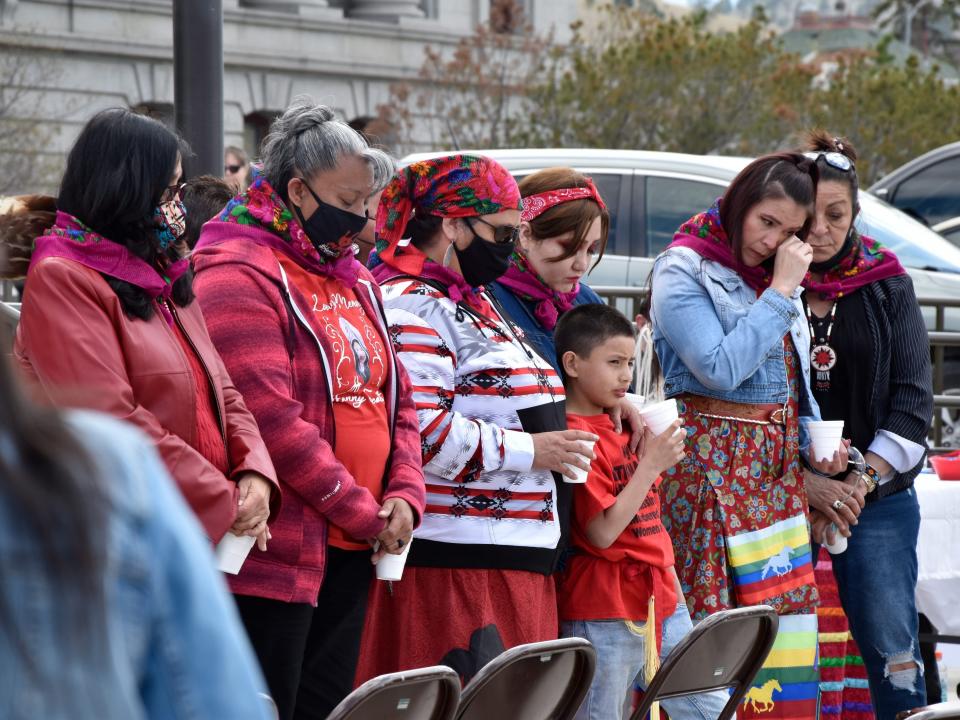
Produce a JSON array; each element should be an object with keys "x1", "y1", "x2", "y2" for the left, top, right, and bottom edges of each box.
[{"x1": 457, "y1": 638, "x2": 597, "y2": 720}]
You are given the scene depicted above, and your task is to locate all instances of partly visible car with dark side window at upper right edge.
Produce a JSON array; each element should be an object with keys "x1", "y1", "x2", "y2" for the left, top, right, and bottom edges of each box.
[{"x1": 869, "y1": 142, "x2": 960, "y2": 226}]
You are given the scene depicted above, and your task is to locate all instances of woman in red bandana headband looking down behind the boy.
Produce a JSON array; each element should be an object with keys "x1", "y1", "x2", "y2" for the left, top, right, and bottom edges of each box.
[{"x1": 489, "y1": 167, "x2": 610, "y2": 369}]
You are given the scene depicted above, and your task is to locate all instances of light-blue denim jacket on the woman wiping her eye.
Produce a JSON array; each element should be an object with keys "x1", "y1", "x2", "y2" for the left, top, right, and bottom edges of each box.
[{"x1": 651, "y1": 247, "x2": 820, "y2": 436}]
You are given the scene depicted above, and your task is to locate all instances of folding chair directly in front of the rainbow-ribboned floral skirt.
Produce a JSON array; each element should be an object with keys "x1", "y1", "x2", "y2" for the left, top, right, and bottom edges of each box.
[{"x1": 630, "y1": 605, "x2": 779, "y2": 720}]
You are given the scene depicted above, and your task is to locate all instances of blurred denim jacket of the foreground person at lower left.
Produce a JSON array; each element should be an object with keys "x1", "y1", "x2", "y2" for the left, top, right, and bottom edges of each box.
[{"x1": 0, "y1": 412, "x2": 270, "y2": 720}]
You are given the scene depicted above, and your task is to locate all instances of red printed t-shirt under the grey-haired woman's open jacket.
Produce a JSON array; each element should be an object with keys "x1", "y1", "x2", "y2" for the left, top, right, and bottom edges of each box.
[{"x1": 277, "y1": 253, "x2": 390, "y2": 550}]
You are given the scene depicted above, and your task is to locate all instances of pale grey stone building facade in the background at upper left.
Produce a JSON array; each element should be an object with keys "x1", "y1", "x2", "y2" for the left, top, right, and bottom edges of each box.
[{"x1": 0, "y1": 0, "x2": 579, "y2": 190}]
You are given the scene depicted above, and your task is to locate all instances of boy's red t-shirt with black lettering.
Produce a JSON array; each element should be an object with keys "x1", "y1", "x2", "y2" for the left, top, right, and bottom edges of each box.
[{"x1": 557, "y1": 414, "x2": 677, "y2": 621}]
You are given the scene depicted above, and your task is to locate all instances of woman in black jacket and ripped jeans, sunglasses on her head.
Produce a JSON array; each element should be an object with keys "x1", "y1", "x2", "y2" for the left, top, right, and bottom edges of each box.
[{"x1": 804, "y1": 133, "x2": 933, "y2": 720}]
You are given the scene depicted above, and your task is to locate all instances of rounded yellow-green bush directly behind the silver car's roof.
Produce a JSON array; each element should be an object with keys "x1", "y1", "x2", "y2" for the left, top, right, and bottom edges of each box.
[{"x1": 524, "y1": 8, "x2": 812, "y2": 154}]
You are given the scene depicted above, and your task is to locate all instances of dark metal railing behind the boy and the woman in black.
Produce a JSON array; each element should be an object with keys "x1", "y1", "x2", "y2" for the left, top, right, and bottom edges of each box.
[{"x1": 593, "y1": 285, "x2": 960, "y2": 450}]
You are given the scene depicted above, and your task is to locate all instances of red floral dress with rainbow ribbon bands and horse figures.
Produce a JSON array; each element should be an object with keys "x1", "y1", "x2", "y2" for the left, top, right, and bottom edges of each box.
[{"x1": 661, "y1": 342, "x2": 818, "y2": 720}]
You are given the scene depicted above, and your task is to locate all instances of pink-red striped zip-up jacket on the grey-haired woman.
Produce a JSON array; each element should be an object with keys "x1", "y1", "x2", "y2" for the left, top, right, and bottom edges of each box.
[{"x1": 193, "y1": 221, "x2": 425, "y2": 605}]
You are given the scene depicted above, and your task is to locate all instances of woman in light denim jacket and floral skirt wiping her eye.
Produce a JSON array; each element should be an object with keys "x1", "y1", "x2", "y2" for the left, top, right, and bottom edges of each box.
[{"x1": 651, "y1": 153, "x2": 845, "y2": 718}]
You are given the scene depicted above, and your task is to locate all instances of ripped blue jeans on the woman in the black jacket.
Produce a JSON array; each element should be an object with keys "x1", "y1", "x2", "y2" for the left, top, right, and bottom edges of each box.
[{"x1": 832, "y1": 488, "x2": 928, "y2": 720}]
